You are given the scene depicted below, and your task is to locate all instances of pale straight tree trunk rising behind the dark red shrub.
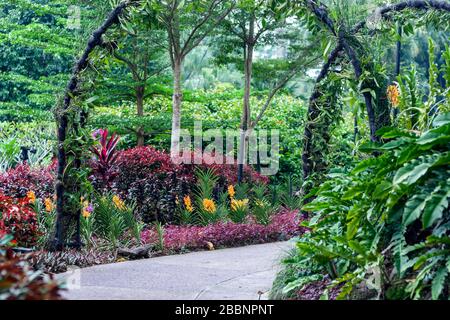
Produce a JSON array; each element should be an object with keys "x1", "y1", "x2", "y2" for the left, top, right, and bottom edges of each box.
[{"x1": 170, "y1": 57, "x2": 183, "y2": 156}]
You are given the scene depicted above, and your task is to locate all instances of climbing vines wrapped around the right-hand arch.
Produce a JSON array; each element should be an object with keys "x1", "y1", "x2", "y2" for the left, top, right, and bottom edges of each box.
[{"x1": 288, "y1": 0, "x2": 450, "y2": 202}]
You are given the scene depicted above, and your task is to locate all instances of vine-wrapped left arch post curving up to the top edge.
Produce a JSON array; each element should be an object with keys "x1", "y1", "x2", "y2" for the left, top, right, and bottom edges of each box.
[{"x1": 48, "y1": 0, "x2": 138, "y2": 250}]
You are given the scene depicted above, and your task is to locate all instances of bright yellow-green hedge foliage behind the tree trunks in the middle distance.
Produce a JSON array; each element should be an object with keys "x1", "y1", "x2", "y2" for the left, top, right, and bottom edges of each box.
[{"x1": 89, "y1": 89, "x2": 306, "y2": 182}]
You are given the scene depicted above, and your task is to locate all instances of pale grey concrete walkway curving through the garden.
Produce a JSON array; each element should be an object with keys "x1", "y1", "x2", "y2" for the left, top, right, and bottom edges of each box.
[{"x1": 64, "y1": 242, "x2": 292, "y2": 300}]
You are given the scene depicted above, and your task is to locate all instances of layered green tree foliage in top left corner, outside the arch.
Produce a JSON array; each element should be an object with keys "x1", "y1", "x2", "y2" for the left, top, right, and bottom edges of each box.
[{"x1": 0, "y1": 0, "x2": 103, "y2": 110}]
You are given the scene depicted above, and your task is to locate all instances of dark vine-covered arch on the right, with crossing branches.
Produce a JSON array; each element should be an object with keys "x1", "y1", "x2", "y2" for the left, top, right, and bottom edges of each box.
[{"x1": 302, "y1": 0, "x2": 450, "y2": 203}]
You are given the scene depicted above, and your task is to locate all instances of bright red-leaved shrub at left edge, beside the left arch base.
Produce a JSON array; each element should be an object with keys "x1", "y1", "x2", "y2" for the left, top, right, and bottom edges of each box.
[{"x1": 0, "y1": 193, "x2": 39, "y2": 246}]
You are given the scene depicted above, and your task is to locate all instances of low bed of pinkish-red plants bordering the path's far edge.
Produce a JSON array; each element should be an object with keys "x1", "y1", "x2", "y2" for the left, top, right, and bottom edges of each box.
[{"x1": 23, "y1": 209, "x2": 305, "y2": 273}]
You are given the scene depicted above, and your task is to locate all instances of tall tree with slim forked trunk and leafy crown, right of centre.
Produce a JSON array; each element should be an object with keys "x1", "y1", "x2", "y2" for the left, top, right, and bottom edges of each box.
[{"x1": 216, "y1": 0, "x2": 316, "y2": 182}]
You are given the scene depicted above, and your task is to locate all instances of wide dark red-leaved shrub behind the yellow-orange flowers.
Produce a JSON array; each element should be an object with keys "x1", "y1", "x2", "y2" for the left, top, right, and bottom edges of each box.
[{"x1": 112, "y1": 147, "x2": 268, "y2": 222}]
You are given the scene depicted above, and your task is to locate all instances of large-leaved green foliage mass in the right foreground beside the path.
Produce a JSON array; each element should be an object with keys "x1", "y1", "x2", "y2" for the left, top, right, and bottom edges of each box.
[{"x1": 289, "y1": 114, "x2": 450, "y2": 299}]
